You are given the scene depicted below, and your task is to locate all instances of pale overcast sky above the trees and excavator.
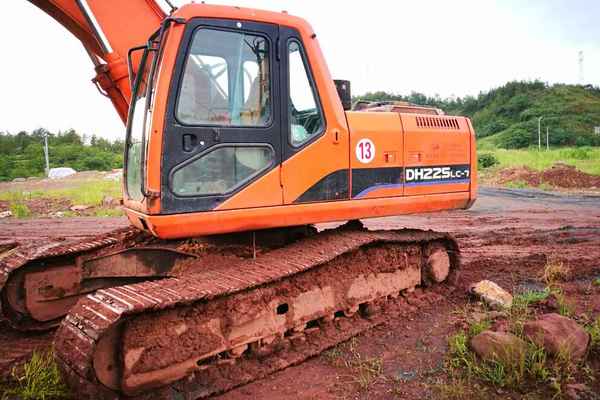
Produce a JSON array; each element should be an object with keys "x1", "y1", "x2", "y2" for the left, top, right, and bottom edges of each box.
[{"x1": 0, "y1": 0, "x2": 600, "y2": 139}]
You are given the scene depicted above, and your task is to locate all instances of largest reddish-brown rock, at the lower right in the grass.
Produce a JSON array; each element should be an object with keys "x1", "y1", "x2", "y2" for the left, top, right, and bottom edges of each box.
[{"x1": 523, "y1": 313, "x2": 590, "y2": 360}]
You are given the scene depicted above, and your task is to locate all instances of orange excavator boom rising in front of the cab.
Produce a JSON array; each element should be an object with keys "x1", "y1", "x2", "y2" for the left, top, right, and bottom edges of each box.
[{"x1": 29, "y1": 0, "x2": 166, "y2": 123}]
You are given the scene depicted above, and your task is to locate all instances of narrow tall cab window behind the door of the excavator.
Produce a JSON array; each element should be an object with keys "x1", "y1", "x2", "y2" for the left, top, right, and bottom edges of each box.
[{"x1": 288, "y1": 40, "x2": 324, "y2": 147}]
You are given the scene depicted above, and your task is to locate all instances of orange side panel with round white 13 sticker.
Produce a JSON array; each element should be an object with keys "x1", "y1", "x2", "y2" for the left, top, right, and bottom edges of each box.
[{"x1": 346, "y1": 112, "x2": 404, "y2": 199}]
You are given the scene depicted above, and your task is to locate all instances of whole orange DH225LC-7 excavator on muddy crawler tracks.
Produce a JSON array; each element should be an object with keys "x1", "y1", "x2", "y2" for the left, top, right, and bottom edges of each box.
[{"x1": 0, "y1": 0, "x2": 477, "y2": 399}]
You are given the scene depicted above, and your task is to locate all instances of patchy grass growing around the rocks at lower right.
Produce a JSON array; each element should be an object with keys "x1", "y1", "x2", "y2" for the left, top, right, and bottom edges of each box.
[{"x1": 446, "y1": 278, "x2": 600, "y2": 399}]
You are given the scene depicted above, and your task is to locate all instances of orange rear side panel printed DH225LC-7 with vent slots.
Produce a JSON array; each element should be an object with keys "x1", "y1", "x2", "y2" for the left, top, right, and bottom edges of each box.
[{"x1": 400, "y1": 114, "x2": 472, "y2": 196}]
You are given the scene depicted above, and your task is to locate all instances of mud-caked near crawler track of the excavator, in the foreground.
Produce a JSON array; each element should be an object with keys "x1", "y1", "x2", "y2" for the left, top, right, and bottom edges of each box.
[{"x1": 55, "y1": 228, "x2": 460, "y2": 399}]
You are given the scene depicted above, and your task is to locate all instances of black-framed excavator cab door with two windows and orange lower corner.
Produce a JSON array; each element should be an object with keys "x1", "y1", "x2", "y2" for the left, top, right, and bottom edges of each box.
[{"x1": 161, "y1": 18, "x2": 283, "y2": 214}]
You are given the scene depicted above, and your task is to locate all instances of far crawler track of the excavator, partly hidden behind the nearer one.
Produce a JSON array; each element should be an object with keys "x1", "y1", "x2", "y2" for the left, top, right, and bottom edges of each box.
[{"x1": 0, "y1": 227, "x2": 314, "y2": 331}]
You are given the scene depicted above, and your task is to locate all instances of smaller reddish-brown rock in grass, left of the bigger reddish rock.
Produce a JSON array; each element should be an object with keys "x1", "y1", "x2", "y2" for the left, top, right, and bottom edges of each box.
[{"x1": 470, "y1": 331, "x2": 527, "y2": 364}]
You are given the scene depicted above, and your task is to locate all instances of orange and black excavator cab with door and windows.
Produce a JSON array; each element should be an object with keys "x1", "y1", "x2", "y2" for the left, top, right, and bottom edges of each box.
[{"x1": 124, "y1": 5, "x2": 348, "y2": 237}]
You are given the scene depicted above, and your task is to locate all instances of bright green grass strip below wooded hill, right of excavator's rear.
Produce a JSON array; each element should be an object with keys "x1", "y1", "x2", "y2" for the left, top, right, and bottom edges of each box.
[{"x1": 477, "y1": 145, "x2": 600, "y2": 175}]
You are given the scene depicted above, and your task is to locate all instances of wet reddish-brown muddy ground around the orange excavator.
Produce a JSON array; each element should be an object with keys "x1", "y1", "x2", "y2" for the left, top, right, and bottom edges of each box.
[{"x1": 0, "y1": 188, "x2": 600, "y2": 400}]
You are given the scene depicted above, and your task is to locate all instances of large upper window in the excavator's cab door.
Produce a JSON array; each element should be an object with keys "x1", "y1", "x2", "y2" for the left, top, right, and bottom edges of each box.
[{"x1": 176, "y1": 28, "x2": 271, "y2": 127}]
